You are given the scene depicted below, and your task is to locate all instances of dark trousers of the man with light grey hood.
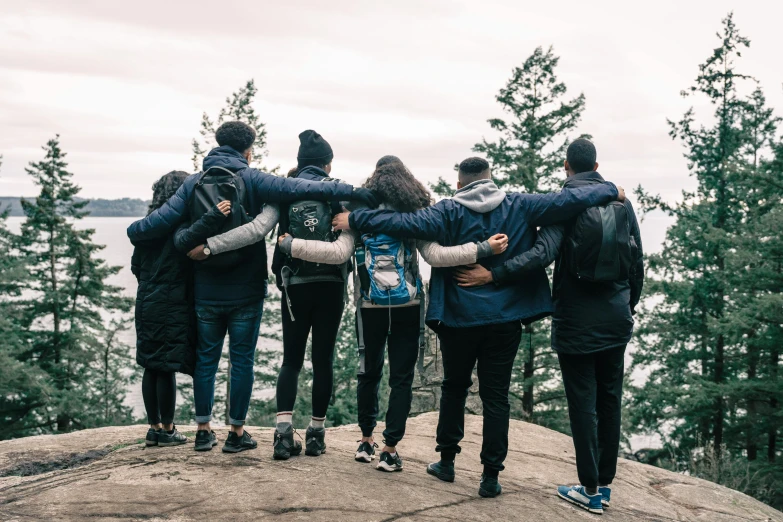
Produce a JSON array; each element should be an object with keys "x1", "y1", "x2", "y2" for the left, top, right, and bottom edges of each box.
[{"x1": 435, "y1": 321, "x2": 522, "y2": 471}]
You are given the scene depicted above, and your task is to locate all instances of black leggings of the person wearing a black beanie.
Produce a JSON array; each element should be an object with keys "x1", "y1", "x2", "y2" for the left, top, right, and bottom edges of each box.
[{"x1": 277, "y1": 282, "x2": 345, "y2": 418}]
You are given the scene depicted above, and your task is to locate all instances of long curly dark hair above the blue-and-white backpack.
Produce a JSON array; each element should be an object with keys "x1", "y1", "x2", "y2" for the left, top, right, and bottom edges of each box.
[{"x1": 362, "y1": 156, "x2": 432, "y2": 212}]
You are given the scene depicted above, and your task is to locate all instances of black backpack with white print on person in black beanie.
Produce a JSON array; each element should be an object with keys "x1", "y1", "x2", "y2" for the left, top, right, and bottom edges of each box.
[{"x1": 287, "y1": 178, "x2": 345, "y2": 277}]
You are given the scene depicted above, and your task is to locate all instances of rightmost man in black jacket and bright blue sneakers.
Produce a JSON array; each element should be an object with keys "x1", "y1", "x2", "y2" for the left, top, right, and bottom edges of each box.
[{"x1": 456, "y1": 139, "x2": 644, "y2": 512}]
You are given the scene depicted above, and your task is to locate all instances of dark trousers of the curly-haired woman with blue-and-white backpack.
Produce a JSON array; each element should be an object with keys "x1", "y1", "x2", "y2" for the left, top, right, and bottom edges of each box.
[{"x1": 356, "y1": 306, "x2": 421, "y2": 446}]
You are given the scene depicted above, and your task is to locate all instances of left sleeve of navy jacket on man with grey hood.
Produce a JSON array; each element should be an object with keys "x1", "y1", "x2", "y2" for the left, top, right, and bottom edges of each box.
[{"x1": 348, "y1": 200, "x2": 449, "y2": 242}]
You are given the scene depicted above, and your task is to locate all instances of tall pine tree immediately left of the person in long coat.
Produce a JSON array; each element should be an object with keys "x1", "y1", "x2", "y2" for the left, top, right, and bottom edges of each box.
[{"x1": 15, "y1": 136, "x2": 131, "y2": 431}]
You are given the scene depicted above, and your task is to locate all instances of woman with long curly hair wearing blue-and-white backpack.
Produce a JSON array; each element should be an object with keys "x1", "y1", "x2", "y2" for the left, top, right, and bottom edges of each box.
[{"x1": 279, "y1": 156, "x2": 507, "y2": 471}]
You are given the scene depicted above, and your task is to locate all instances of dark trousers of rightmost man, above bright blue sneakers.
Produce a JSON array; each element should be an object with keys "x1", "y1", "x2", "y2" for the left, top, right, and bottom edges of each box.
[{"x1": 557, "y1": 346, "x2": 625, "y2": 488}]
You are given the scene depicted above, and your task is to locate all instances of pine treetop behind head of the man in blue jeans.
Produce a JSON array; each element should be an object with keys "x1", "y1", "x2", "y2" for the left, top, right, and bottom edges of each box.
[{"x1": 191, "y1": 80, "x2": 280, "y2": 174}]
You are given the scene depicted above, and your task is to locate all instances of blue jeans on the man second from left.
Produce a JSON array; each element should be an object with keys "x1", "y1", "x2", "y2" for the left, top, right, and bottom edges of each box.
[{"x1": 193, "y1": 299, "x2": 264, "y2": 426}]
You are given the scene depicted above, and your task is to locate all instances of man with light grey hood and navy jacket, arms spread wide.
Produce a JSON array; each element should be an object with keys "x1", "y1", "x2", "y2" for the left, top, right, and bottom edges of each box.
[{"x1": 334, "y1": 158, "x2": 625, "y2": 497}]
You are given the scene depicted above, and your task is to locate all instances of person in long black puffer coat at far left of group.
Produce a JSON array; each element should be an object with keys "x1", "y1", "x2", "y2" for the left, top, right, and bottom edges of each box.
[{"x1": 131, "y1": 171, "x2": 231, "y2": 446}]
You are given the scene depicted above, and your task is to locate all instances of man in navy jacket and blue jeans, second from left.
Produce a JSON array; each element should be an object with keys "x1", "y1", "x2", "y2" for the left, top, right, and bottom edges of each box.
[{"x1": 128, "y1": 121, "x2": 377, "y2": 453}]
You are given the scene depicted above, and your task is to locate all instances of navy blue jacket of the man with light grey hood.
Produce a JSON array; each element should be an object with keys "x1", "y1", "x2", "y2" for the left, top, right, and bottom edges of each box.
[{"x1": 350, "y1": 182, "x2": 617, "y2": 331}]
